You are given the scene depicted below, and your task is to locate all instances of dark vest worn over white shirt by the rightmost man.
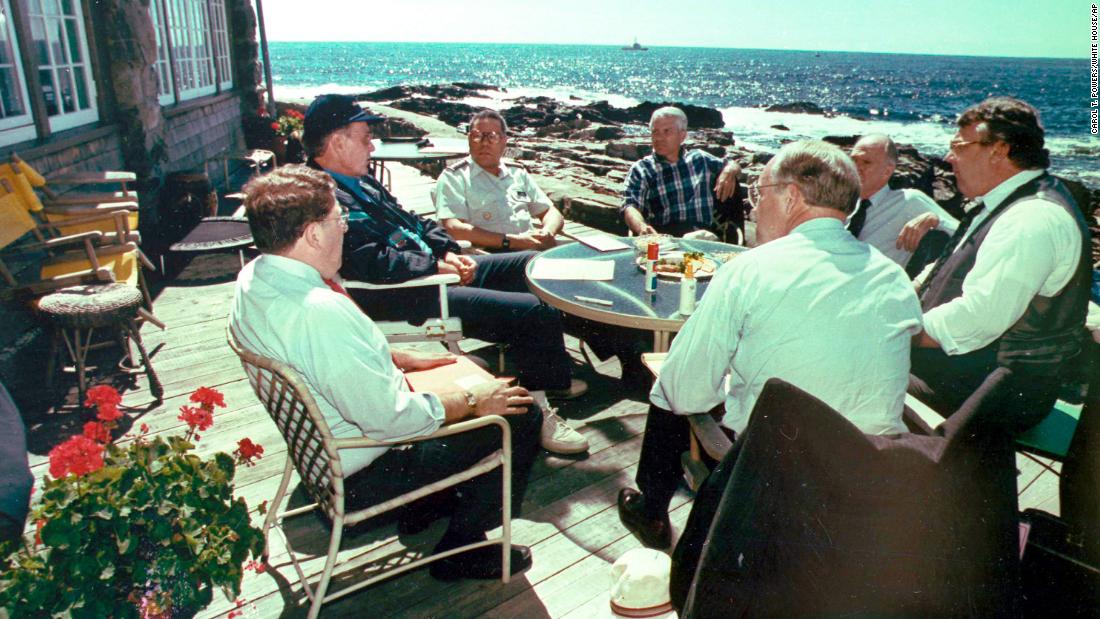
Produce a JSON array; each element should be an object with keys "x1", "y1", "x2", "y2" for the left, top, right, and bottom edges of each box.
[{"x1": 921, "y1": 174, "x2": 1092, "y2": 376}]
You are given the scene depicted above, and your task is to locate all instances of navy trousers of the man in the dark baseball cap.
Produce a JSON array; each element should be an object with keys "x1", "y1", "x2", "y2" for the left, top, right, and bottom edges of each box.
[{"x1": 352, "y1": 252, "x2": 571, "y2": 389}]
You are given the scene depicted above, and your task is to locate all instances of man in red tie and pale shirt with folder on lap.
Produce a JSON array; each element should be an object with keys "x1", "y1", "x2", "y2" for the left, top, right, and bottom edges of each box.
[{"x1": 229, "y1": 166, "x2": 542, "y2": 579}]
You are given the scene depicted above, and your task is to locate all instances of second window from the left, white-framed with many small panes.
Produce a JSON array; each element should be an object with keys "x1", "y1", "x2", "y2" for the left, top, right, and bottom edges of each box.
[{"x1": 26, "y1": 0, "x2": 99, "y2": 131}]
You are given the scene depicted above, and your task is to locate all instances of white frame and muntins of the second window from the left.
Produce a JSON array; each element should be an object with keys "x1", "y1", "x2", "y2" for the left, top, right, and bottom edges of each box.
[{"x1": 26, "y1": 0, "x2": 99, "y2": 132}]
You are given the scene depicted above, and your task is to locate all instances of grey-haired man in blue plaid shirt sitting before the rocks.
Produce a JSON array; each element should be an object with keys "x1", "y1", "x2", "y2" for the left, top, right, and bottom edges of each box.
[{"x1": 619, "y1": 107, "x2": 741, "y2": 236}]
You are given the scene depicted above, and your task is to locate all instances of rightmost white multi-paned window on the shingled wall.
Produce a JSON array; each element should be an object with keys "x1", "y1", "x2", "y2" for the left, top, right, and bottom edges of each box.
[{"x1": 149, "y1": 0, "x2": 233, "y2": 104}]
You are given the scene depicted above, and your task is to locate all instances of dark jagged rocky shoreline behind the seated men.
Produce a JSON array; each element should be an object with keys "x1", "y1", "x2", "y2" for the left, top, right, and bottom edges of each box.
[{"x1": 281, "y1": 82, "x2": 1100, "y2": 263}]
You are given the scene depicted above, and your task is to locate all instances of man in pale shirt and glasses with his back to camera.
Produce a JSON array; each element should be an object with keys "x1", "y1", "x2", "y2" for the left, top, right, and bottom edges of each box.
[{"x1": 618, "y1": 142, "x2": 921, "y2": 548}]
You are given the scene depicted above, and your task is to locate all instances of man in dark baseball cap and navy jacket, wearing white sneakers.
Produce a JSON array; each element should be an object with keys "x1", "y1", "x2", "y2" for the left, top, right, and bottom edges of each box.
[{"x1": 304, "y1": 95, "x2": 589, "y2": 453}]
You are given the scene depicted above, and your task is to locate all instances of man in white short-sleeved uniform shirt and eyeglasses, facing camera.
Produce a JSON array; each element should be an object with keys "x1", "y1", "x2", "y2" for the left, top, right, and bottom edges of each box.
[{"x1": 435, "y1": 110, "x2": 564, "y2": 252}]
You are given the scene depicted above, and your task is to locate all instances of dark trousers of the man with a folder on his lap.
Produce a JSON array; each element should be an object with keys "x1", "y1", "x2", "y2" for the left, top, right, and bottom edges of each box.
[{"x1": 344, "y1": 406, "x2": 542, "y2": 545}]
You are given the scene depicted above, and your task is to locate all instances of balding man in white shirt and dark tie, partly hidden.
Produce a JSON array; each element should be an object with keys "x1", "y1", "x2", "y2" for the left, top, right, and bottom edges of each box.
[{"x1": 847, "y1": 133, "x2": 958, "y2": 270}]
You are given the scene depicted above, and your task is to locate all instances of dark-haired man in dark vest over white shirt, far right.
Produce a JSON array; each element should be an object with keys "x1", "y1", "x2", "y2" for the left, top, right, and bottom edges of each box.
[{"x1": 910, "y1": 97, "x2": 1090, "y2": 431}]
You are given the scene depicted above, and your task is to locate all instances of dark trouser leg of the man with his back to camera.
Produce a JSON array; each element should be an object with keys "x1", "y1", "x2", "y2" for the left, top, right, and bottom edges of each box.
[{"x1": 634, "y1": 405, "x2": 734, "y2": 516}]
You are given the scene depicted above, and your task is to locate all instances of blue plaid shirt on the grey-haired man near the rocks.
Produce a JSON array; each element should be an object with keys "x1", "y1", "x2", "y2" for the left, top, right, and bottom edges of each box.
[{"x1": 619, "y1": 151, "x2": 725, "y2": 226}]
